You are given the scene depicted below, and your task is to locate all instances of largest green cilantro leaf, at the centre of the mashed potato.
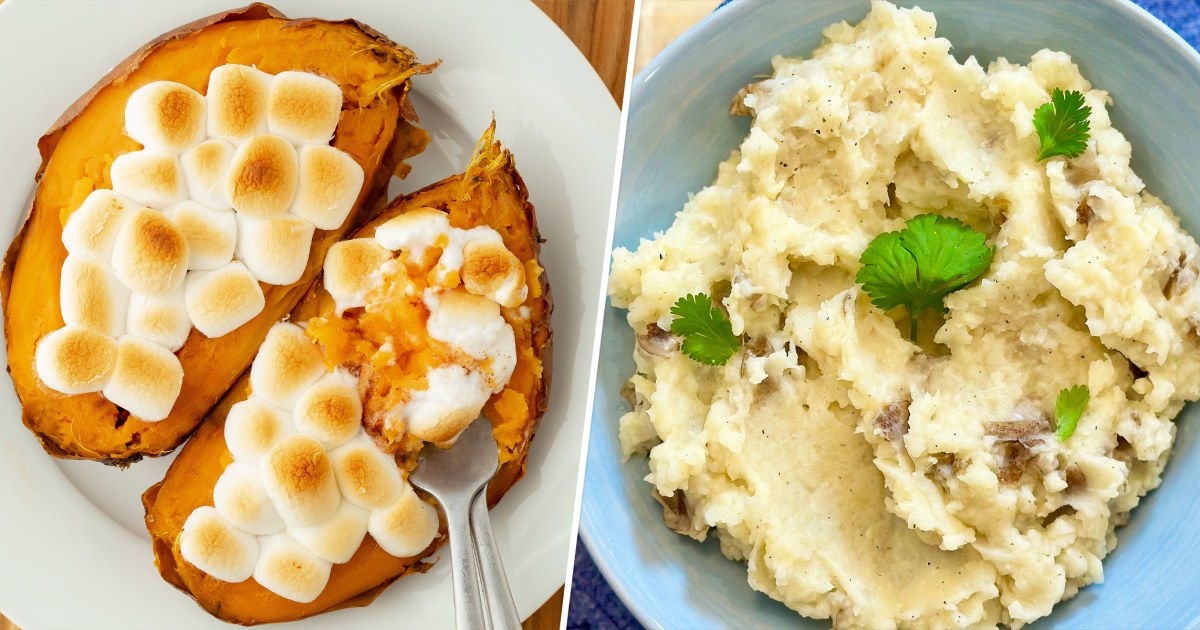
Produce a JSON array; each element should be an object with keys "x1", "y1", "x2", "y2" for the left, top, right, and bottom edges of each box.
[{"x1": 854, "y1": 215, "x2": 995, "y2": 342}]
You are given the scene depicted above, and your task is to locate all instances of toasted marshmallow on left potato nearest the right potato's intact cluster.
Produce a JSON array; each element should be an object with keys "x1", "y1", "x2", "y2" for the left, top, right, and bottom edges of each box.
[{"x1": 185, "y1": 262, "x2": 266, "y2": 338}]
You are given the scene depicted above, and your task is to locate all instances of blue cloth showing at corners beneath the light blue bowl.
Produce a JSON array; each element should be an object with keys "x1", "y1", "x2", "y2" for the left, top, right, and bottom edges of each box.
[{"x1": 566, "y1": 0, "x2": 1200, "y2": 630}]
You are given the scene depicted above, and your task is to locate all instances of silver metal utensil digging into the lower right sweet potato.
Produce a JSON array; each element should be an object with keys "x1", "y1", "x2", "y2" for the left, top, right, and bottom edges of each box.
[{"x1": 409, "y1": 418, "x2": 521, "y2": 630}]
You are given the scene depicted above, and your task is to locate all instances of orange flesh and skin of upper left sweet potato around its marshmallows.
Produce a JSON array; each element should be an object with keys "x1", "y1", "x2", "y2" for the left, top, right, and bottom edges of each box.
[{"x1": 0, "y1": 4, "x2": 436, "y2": 466}]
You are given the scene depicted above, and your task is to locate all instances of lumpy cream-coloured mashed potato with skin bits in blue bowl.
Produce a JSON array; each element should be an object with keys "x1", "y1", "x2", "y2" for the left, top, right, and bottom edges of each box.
[{"x1": 610, "y1": 1, "x2": 1200, "y2": 628}]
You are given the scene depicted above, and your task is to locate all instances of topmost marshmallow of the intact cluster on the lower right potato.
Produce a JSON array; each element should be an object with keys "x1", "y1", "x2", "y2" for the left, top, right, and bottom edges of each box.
[{"x1": 250, "y1": 323, "x2": 325, "y2": 409}]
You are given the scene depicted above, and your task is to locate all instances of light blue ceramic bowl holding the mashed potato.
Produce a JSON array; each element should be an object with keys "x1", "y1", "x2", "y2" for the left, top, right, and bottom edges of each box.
[{"x1": 581, "y1": 0, "x2": 1200, "y2": 628}]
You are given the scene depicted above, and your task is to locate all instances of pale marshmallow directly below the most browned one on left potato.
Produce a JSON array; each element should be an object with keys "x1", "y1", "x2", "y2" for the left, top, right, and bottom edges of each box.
[{"x1": 238, "y1": 214, "x2": 313, "y2": 284}]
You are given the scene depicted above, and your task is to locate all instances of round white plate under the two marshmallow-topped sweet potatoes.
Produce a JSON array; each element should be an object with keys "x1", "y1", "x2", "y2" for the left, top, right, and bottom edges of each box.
[{"x1": 0, "y1": 0, "x2": 619, "y2": 630}]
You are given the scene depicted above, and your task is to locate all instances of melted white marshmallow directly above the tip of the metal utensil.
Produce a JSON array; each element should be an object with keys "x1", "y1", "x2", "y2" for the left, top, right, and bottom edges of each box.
[{"x1": 401, "y1": 365, "x2": 491, "y2": 445}]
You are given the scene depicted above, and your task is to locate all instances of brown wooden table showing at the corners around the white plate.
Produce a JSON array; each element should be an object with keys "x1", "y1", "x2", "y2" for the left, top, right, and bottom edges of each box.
[{"x1": 0, "y1": 0, "x2": 634, "y2": 630}]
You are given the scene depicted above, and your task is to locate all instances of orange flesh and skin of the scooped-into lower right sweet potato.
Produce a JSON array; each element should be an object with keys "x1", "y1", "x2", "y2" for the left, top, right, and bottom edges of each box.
[{"x1": 142, "y1": 128, "x2": 552, "y2": 625}]
